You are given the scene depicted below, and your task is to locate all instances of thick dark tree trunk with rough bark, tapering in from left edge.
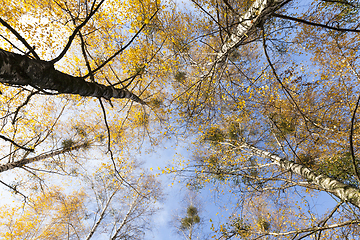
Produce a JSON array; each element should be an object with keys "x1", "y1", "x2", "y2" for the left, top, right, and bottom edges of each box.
[{"x1": 0, "y1": 49, "x2": 144, "y2": 104}]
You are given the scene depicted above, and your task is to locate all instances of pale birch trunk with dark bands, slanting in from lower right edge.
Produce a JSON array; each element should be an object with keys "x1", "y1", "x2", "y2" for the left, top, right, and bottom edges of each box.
[{"x1": 239, "y1": 143, "x2": 360, "y2": 208}]
